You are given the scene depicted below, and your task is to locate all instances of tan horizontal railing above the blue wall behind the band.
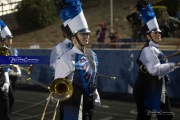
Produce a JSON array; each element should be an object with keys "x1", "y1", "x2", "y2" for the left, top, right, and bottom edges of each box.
[{"x1": 13, "y1": 42, "x2": 180, "y2": 50}]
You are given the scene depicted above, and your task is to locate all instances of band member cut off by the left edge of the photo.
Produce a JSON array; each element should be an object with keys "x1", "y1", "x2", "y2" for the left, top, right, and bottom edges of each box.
[{"x1": 0, "y1": 20, "x2": 14, "y2": 120}]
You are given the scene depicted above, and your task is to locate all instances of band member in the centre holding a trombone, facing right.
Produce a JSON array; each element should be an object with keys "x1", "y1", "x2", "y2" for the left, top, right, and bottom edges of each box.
[{"x1": 54, "y1": 0, "x2": 100, "y2": 120}]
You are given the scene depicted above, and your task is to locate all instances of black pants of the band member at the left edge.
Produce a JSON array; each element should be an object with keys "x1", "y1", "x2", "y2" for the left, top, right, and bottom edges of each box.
[{"x1": 0, "y1": 84, "x2": 11, "y2": 120}]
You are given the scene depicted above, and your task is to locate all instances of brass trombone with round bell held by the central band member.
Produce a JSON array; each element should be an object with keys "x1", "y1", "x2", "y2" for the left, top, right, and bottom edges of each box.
[{"x1": 41, "y1": 78, "x2": 73, "y2": 120}]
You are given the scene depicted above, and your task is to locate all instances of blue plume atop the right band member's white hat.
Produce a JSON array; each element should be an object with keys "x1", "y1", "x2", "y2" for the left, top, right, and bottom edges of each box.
[{"x1": 139, "y1": 3, "x2": 156, "y2": 23}]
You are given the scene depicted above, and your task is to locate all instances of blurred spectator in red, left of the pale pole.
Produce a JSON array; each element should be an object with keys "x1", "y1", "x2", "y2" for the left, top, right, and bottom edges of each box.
[{"x1": 96, "y1": 22, "x2": 107, "y2": 48}]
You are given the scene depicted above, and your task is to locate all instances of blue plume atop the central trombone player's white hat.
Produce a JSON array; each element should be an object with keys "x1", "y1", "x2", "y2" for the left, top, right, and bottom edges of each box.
[{"x1": 60, "y1": 0, "x2": 82, "y2": 21}]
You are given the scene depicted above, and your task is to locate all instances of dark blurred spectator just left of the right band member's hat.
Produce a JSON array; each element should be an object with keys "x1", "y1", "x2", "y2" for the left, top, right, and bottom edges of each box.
[{"x1": 126, "y1": 10, "x2": 142, "y2": 42}]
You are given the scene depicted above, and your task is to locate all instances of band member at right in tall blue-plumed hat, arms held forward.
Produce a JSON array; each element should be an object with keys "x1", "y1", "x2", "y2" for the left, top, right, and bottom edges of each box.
[{"x1": 133, "y1": 0, "x2": 179, "y2": 120}]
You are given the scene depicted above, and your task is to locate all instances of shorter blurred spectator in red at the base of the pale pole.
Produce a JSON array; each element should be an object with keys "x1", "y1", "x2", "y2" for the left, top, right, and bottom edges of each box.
[{"x1": 109, "y1": 32, "x2": 118, "y2": 48}]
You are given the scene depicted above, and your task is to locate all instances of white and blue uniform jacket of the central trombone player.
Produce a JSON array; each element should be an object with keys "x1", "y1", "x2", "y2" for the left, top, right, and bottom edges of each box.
[{"x1": 55, "y1": 46, "x2": 98, "y2": 95}]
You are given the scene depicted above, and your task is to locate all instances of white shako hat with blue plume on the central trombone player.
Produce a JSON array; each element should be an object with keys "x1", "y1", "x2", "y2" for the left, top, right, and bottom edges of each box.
[{"x1": 59, "y1": 0, "x2": 90, "y2": 37}]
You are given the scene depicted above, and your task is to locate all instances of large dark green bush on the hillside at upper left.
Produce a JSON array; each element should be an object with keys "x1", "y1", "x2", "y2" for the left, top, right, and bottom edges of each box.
[{"x1": 15, "y1": 0, "x2": 57, "y2": 30}]
